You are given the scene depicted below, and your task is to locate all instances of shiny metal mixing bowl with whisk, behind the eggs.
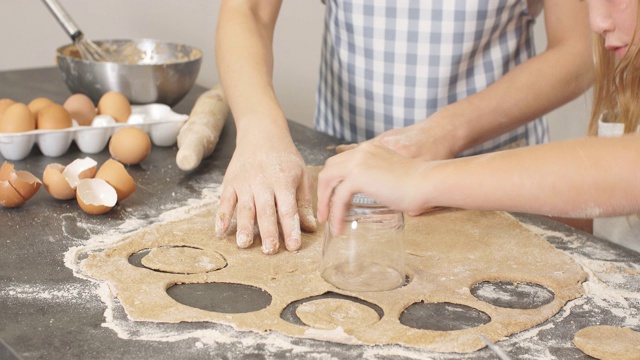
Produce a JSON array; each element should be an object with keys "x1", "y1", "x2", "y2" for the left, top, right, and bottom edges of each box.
[{"x1": 56, "y1": 39, "x2": 202, "y2": 106}]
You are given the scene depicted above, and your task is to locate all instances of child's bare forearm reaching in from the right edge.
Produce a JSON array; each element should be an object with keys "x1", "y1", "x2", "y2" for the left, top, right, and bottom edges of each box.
[{"x1": 418, "y1": 135, "x2": 640, "y2": 218}]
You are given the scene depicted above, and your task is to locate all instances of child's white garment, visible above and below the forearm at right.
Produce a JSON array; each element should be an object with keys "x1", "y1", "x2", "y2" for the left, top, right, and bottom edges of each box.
[{"x1": 593, "y1": 116, "x2": 640, "y2": 252}]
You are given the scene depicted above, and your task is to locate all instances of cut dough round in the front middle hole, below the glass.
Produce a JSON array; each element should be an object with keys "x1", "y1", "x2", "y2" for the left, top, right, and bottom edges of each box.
[{"x1": 296, "y1": 298, "x2": 380, "y2": 332}]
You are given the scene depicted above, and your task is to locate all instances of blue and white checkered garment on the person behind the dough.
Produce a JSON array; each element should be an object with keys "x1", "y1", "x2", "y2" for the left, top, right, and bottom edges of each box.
[{"x1": 314, "y1": 0, "x2": 549, "y2": 155}]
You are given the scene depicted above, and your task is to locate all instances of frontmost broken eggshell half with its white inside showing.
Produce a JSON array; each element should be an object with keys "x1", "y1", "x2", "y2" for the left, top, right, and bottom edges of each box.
[{"x1": 76, "y1": 179, "x2": 118, "y2": 215}]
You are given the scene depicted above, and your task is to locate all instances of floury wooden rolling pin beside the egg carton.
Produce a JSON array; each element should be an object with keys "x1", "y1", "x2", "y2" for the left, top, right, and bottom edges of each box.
[{"x1": 176, "y1": 85, "x2": 229, "y2": 171}]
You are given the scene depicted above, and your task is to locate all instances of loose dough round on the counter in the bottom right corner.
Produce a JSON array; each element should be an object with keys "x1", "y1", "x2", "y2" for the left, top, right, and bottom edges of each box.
[{"x1": 573, "y1": 325, "x2": 640, "y2": 360}]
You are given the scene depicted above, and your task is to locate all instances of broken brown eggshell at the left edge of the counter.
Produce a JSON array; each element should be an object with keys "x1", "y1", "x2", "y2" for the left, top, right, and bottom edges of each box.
[{"x1": 0, "y1": 161, "x2": 42, "y2": 207}]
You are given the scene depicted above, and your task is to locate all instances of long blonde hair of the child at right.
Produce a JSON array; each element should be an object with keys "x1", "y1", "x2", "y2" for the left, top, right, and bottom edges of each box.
[{"x1": 588, "y1": 0, "x2": 640, "y2": 135}]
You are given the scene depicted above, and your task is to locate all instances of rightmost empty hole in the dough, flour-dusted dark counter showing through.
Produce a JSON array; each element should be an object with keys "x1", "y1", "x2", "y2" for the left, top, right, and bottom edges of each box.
[{"x1": 471, "y1": 281, "x2": 554, "y2": 309}]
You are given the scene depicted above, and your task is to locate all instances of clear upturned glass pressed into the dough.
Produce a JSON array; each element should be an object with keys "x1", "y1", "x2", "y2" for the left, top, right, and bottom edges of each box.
[{"x1": 321, "y1": 194, "x2": 406, "y2": 291}]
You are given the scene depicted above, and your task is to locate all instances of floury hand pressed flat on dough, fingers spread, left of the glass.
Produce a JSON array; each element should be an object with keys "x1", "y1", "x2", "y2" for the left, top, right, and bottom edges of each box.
[{"x1": 216, "y1": 134, "x2": 316, "y2": 254}]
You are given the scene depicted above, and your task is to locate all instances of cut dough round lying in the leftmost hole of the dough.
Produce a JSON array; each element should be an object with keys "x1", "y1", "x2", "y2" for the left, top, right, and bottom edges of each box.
[{"x1": 140, "y1": 246, "x2": 227, "y2": 274}]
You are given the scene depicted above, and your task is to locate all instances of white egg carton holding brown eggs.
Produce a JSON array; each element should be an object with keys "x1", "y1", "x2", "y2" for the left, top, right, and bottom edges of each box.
[{"x1": 0, "y1": 104, "x2": 189, "y2": 161}]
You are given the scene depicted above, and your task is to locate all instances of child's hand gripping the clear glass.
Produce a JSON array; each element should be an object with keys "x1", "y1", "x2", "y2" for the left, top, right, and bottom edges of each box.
[{"x1": 318, "y1": 141, "x2": 434, "y2": 234}]
